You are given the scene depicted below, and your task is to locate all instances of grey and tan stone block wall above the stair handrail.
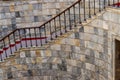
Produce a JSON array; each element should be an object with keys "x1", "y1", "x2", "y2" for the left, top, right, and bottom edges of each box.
[{"x1": 0, "y1": 0, "x2": 76, "y2": 37}]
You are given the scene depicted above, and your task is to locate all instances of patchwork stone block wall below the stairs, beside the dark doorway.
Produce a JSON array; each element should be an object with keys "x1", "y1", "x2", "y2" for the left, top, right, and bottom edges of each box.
[{"x1": 0, "y1": 9, "x2": 120, "y2": 80}]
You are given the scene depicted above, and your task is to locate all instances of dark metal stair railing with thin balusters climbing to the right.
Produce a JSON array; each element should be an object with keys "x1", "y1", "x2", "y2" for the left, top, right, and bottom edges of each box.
[{"x1": 0, "y1": 0, "x2": 119, "y2": 61}]
